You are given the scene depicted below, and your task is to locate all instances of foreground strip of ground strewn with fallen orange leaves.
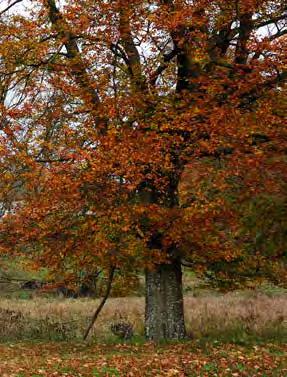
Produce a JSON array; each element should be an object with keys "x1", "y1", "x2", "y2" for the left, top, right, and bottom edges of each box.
[{"x1": 0, "y1": 341, "x2": 287, "y2": 377}]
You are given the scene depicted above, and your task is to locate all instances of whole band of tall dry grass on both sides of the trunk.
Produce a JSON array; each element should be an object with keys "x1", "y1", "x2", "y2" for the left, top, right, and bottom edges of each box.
[{"x1": 0, "y1": 294, "x2": 287, "y2": 340}]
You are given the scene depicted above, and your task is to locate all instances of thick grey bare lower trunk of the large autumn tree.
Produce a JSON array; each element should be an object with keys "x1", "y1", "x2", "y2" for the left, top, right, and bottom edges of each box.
[{"x1": 145, "y1": 260, "x2": 186, "y2": 341}]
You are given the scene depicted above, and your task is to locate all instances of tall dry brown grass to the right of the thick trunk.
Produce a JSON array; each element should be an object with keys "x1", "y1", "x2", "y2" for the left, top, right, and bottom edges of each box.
[{"x1": 185, "y1": 294, "x2": 287, "y2": 337}]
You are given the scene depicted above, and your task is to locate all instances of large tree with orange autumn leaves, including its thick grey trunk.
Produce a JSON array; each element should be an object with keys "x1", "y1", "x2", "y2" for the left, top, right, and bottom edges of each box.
[{"x1": 0, "y1": 0, "x2": 286, "y2": 340}]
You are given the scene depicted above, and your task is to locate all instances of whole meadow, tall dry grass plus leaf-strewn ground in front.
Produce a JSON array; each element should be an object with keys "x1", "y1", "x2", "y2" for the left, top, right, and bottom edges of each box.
[{"x1": 0, "y1": 291, "x2": 287, "y2": 377}]
